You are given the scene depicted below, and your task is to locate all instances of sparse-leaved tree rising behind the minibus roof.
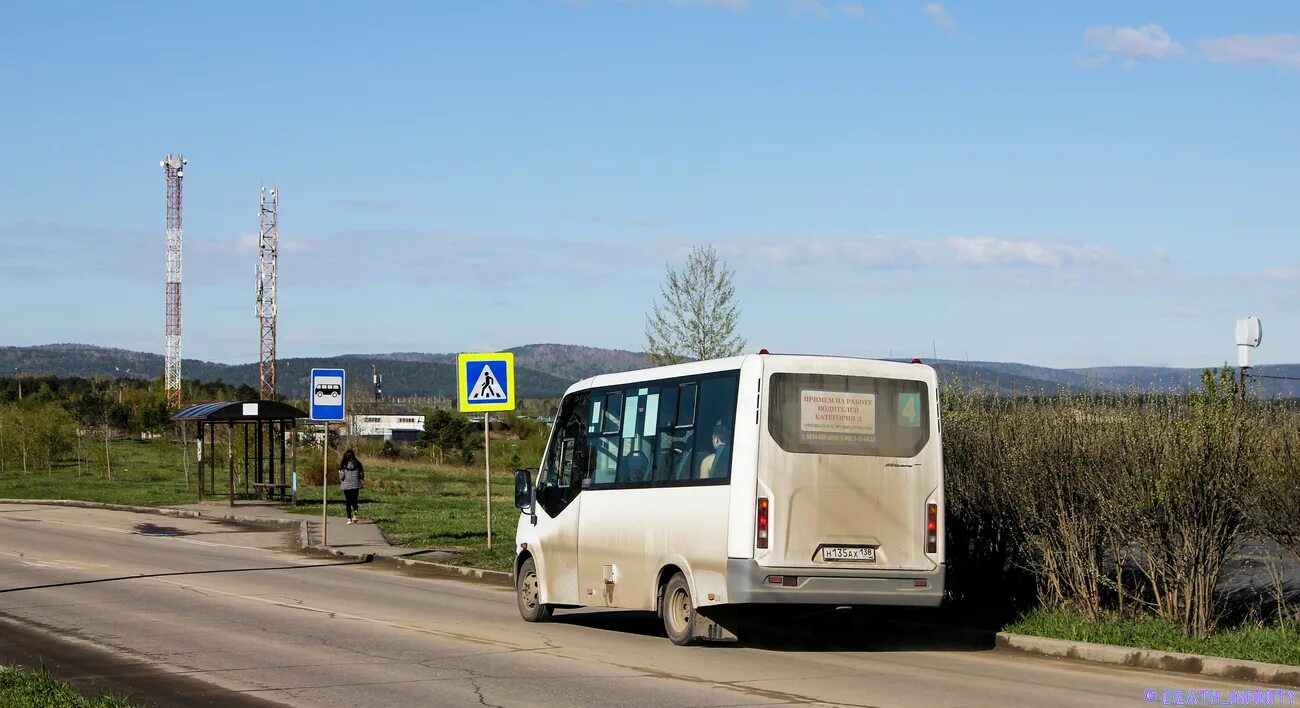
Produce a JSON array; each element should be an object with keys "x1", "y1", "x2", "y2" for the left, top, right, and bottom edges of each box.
[{"x1": 646, "y1": 246, "x2": 745, "y2": 366}]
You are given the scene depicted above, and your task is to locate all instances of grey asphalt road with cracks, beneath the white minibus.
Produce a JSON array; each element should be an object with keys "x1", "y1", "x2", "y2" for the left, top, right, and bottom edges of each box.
[{"x1": 0, "y1": 505, "x2": 1279, "y2": 708}]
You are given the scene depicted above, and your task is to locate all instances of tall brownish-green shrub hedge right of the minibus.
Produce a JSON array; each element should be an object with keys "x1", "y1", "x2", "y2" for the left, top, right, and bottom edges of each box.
[{"x1": 941, "y1": 370, "x2": 1300, "y2": 637}]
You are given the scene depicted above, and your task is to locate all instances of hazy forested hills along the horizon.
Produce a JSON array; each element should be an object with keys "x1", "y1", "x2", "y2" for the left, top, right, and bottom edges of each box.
[{"x1": 0, "y1": 344, "x2": 1300, "y2": 398}]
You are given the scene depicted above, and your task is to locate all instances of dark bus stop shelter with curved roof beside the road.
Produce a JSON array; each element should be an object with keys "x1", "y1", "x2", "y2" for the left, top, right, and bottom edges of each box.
[{"x1": 172, "y1": 400, "x2": 307, "y2": 507}]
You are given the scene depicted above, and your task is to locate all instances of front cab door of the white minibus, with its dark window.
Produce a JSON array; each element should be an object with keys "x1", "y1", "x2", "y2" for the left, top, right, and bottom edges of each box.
[{"x1": 527, "y1": 392, "x2": 590, "y2": 605}]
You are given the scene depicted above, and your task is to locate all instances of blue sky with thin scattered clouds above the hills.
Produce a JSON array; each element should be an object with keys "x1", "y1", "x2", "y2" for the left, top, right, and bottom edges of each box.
[{"x1": 0, "y1": 0, "x2": 1300, "y2": 366}]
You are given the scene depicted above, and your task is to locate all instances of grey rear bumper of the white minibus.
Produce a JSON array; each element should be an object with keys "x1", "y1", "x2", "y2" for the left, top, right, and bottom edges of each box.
[{"x1": 727, "y1": 559, "x2": 944, "y2": 607}]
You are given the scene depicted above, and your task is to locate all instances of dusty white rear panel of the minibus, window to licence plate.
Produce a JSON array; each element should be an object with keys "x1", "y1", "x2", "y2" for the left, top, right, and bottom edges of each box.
[{"x1": 755, "y1": 368, "x2": 943, "y2": 570}]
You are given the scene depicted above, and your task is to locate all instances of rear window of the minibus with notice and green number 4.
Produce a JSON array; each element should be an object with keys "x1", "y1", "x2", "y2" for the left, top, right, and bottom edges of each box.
[{"x1": 767, "y1": 374, "x2": 930, "y2": 457}]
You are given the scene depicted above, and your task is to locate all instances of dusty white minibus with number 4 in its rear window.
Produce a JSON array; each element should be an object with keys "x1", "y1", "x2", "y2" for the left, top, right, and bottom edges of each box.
[{"x1": 514, "y1": 352, "x2": 944, "y2": 644}]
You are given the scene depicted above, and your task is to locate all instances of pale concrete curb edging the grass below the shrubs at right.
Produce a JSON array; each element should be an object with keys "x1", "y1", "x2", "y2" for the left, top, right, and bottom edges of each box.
[{"x1": 996, "y1": 631, "x2": 1300, "y2": 687}]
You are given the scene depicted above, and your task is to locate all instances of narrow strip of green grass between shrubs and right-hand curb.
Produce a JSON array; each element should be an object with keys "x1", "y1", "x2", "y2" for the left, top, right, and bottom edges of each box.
[{"x1": 1004, "y1": 609, "x2": 1300, "y2": 666}]
